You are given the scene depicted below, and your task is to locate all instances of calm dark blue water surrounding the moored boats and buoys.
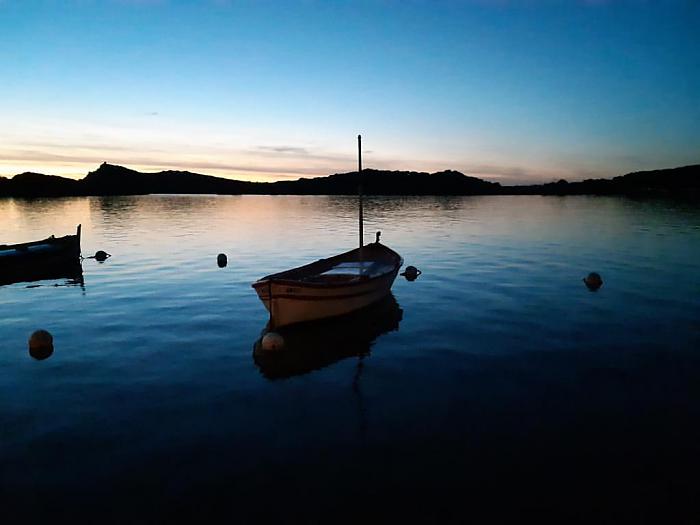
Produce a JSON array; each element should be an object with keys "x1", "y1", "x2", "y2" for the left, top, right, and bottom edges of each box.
[{"x1": 0, "y1": 196, "x2": 700, "y2": 523}]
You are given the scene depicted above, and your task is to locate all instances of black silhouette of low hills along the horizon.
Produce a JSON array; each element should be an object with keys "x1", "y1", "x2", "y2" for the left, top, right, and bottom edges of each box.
[{"x1": 0, "y1": 163, "x2": 700, "y2": 197}]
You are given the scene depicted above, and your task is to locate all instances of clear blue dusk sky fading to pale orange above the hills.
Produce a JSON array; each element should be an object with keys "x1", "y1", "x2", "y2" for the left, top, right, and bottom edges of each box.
[{"x1": 0, "y1": 0, "x2": 700, "y2": 184}]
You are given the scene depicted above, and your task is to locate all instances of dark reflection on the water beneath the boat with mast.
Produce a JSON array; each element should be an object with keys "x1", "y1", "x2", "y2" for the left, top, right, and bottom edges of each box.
[{"x1": 253, "y1": 293, "x2": 403, "y2": 379}]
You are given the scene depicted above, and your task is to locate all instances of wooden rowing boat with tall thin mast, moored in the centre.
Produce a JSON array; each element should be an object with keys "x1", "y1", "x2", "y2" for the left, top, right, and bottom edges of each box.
[{"x1": 252, "y1": 139, "x2": 403, "y2": 330}]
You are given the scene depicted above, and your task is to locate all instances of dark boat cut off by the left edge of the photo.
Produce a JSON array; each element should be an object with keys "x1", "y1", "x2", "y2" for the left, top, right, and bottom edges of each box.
[{"x1": 0, "y1": 225, "x2": 82, "y2": 284}]
